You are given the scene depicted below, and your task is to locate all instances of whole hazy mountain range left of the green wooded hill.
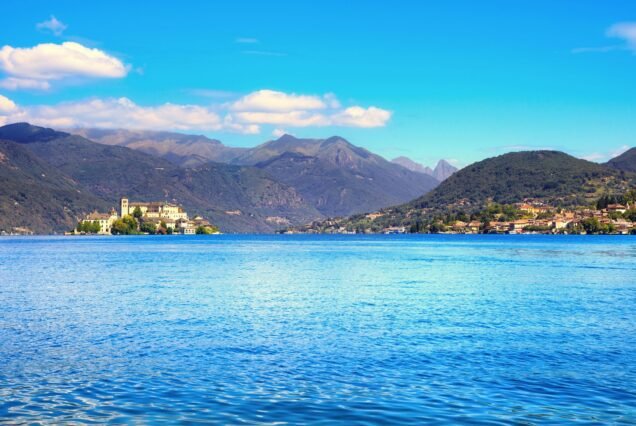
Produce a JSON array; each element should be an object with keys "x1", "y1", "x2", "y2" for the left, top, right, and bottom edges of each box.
[{"x1": 0, "y1": 123, "x2": 438, "y2": 233}]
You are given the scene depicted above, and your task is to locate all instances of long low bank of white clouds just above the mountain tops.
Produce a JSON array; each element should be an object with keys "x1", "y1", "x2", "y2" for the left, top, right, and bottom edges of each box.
[{"x1": 0, "y1": 90, "x2": 392, "y2": 134}]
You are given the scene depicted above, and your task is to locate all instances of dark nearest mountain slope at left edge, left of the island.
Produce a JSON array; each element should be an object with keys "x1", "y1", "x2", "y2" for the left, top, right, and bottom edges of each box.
[{"x1": 0, "y1": 139, "x2": 108, "y2": 233}]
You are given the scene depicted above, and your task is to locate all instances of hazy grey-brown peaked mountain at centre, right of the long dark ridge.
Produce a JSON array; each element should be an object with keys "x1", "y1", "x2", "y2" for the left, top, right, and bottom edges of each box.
[{"x1": 242, "y1": 135, "x2": 438, "y2": 216}]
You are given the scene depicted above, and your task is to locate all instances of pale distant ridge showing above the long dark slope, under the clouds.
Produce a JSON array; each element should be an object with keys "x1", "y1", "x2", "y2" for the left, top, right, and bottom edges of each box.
[{"x1": 69, "y1": 129, "x2": 246, "y2": 167}]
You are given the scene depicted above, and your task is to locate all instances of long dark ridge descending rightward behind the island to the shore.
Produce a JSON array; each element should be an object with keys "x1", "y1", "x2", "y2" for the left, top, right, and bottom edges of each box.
[{"x1": 0, "y1": 123, "x2": 321, "y2": 232}]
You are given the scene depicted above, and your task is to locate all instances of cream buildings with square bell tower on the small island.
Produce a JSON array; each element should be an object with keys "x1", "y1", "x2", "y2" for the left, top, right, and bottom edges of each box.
[{"x1": 75, "y1": 198, "x2": 218, "y2": 235}]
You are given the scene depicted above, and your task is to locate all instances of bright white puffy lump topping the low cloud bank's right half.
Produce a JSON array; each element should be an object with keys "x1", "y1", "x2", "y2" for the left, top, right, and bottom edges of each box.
[{"x1": 230, "y1": 90, "x2": 327, "y2": 112}]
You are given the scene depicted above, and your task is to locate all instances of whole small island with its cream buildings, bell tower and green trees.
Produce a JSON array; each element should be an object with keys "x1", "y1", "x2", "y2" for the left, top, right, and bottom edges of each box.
[{"x1": 73, "y1": 198, "x2": 219, "y2": 235}]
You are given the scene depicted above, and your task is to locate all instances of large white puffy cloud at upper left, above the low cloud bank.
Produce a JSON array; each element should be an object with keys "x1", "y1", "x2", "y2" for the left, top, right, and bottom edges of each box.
[{"x1": 0, "y1": 41, "x2": 129, "y2": 89}]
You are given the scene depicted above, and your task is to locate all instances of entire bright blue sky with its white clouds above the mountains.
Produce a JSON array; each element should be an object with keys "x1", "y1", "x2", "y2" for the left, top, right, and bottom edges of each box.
[{"x1": 0, "y1": 0, "x2": 636, "y2": 166}]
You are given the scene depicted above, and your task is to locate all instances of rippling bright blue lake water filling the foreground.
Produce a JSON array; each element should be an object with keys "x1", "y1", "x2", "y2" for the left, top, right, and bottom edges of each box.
[{"x1": 0, "y1": 235, "x2": 636, "y2": 424}]
